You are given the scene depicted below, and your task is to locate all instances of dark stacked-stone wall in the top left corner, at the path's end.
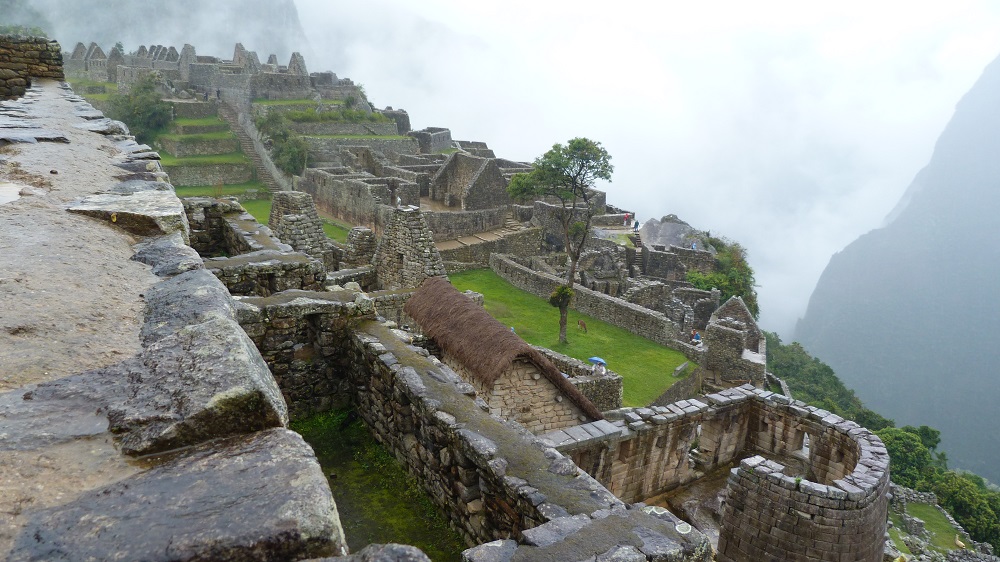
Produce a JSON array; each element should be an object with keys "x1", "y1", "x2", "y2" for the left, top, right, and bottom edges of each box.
[{"x1": 0, "y1": 35, "x2": 64, "y2": 100}]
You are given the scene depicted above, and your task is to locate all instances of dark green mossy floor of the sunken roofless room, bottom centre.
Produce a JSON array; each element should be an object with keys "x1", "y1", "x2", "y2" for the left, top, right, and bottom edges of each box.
[{"x1": 291, "y1": 410, "x2": 466, "y2": 562}]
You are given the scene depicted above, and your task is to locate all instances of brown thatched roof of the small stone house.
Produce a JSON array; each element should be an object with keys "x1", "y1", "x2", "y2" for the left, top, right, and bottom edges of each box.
[{"x1": 403, "y1": 277, "x2": 603, "y2": 420}]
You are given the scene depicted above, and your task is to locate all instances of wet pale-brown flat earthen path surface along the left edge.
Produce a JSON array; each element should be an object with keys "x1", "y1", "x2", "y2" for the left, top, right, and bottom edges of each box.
[{"x1": 0, "y1": 81, "x2": 156, "y2": 559}]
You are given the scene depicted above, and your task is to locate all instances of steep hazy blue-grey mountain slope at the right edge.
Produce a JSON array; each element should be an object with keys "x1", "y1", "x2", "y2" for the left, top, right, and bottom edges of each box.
[{"x1": 795, "y1": 51, "x2": 1000, "y2": 482}]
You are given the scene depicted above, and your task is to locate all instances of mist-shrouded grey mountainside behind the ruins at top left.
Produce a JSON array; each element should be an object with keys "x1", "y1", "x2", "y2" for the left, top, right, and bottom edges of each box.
[{"x1": 0, "y1": 0, "x2": 308, "y2": 60}]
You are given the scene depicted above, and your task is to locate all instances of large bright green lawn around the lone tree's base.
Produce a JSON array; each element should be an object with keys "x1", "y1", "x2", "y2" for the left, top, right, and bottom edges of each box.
[{"x1": 449, "y1": 269, "x2": 687, "y2": 406}]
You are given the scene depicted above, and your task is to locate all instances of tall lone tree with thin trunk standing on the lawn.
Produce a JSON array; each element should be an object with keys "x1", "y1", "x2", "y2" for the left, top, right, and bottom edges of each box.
[{"x1": 507, "y1": 138, "x2": 614, "y2": 343}]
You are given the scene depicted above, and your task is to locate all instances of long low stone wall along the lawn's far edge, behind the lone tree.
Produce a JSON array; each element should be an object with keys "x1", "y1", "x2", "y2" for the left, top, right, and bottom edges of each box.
[{"x1": 490, "y1": 254, "x2": 680, "y2": 348}]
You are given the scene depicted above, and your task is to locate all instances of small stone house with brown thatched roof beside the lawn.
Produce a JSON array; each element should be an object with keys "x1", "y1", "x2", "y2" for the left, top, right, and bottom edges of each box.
[{"x1": 404, "y1": 277, "x2": 603, "y2": 433}]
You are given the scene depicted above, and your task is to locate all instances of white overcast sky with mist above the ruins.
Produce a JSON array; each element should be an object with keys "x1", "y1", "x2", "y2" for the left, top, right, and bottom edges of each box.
[{"x1": 292, "y1": 0, "x2": 1000, "y2": 339}]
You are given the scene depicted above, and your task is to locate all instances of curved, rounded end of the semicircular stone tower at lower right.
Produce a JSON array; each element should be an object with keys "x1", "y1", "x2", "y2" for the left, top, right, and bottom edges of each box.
[{"x1": 717, "y1": 388, "x2": 889, "y2": 562}]
